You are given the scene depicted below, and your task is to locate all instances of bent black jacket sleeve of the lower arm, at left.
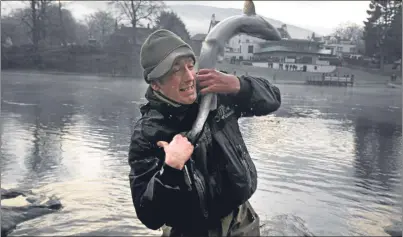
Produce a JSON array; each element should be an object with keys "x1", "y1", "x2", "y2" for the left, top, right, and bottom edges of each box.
[{"x1": 129, "y1": 122, "x2": 185, "y2": 230}]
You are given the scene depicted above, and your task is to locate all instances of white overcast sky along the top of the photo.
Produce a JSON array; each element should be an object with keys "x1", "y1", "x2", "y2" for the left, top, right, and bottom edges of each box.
[{"x1": 1, "y1": 1, "x2": 369, "y2": 35}]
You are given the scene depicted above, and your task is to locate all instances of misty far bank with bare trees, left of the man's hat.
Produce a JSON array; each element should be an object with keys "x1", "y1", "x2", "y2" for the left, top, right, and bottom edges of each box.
[{"x1": 1, "y1": 0, "x2": 190, "y2": 76}]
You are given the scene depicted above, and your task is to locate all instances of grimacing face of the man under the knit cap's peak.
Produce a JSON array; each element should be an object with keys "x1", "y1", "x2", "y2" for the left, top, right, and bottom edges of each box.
[{"x1": 152, "y1": 57, "x2": 197, "y2": 104}]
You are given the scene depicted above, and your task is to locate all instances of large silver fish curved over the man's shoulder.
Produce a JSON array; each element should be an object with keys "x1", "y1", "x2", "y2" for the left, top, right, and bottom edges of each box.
[{"x1": 187, "y1": 0, "x2": 281, "y2": 143}]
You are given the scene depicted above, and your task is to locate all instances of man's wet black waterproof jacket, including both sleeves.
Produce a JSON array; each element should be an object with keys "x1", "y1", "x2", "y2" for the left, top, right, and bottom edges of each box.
[{"x1": 129, "y1": 76, "x2": 281, "y2": 233}]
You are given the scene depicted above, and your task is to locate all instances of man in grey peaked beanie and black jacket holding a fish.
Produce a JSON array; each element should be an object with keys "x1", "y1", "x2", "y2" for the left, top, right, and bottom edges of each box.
[{"x1": 129, "y1": 30, "x2": 281, "y2": 236}]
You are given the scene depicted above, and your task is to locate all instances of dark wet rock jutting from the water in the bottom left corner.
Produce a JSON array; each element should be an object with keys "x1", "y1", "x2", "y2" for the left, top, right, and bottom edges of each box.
[{"x1": 1, "y1": 189, "x2": 62, "y2": 236}]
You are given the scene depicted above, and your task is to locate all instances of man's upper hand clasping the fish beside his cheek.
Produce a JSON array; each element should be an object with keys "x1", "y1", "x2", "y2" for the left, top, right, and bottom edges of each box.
[{"x1": 196, "y1": 69, "x2": 241, "y2": 94}]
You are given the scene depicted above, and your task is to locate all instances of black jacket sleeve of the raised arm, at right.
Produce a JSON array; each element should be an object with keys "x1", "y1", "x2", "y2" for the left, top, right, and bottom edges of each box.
[{"x1": 230, "y1": 76, "x2": 281, "y2": 117}]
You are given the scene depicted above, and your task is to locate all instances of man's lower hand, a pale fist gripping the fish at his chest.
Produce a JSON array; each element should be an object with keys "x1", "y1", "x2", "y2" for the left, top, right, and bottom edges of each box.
[{"x1": 157, "y1": 134, "x2": 194, "y2": 170}]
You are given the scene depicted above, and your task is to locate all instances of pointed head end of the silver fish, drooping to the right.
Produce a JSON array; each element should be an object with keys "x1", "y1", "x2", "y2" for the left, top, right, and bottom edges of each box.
[{"x1": 241, "y1": 15, "x2": 281, "y2": 41}]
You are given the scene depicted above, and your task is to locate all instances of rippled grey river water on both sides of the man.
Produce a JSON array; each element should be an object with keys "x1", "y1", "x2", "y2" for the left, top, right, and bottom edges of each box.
[{"x1": 0, "y1": 72, "x2": 402, "y2": 236}]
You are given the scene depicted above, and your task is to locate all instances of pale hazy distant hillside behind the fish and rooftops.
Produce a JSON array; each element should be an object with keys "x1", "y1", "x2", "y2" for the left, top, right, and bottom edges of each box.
[{"x1": 169, "y1": 4, "x2": 318, "y2": 39}]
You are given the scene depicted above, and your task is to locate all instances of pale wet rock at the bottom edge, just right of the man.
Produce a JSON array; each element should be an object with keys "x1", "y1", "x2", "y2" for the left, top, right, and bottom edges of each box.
[{"x1": 260, "y1": 215, "x2": 314, "y2": 236}]
